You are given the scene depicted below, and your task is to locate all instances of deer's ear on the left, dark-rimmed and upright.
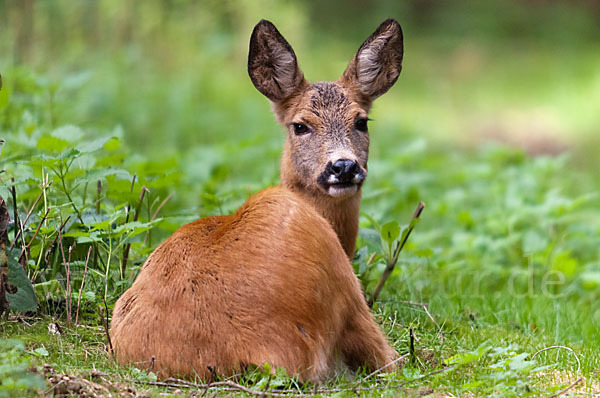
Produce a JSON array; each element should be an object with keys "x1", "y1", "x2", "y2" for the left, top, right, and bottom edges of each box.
[{"x1": 248, "y1": 19, "x2": 304, "y2": 102}]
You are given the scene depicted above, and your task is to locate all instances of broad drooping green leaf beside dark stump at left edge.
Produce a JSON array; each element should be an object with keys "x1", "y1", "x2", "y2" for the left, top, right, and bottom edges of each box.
[{"x1": 6, "y1": 249, "x2": 37, "y2": 312}]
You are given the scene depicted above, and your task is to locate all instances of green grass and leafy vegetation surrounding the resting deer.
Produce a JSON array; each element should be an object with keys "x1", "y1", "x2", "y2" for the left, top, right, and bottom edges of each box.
[{"x1": 0, "y1": 0, "x2": 600, "y2": 396}]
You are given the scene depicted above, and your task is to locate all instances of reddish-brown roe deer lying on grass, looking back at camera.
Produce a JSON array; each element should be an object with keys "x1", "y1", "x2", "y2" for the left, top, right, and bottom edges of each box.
[{"x1": 111, "y1": 19, "x2": 403, "y2": 382}]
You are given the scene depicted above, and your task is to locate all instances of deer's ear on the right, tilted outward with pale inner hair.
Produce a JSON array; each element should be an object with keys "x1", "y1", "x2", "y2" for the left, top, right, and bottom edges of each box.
[{"x1": 342, "y1": 19, "x2": 404, "y2": 100}]
